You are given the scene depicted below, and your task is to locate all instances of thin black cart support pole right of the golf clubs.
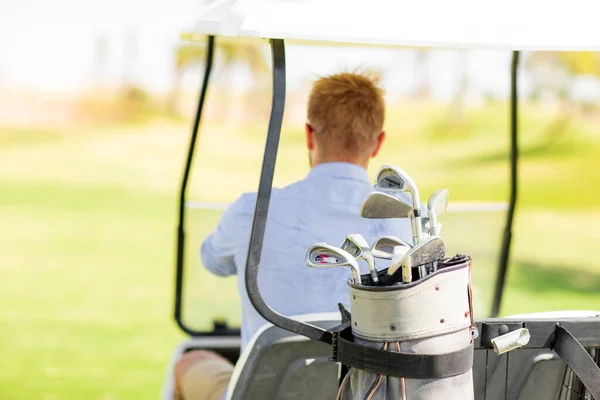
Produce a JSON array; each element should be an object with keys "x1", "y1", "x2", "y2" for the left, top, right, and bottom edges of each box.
[{"x1": 492, "y1": 51, "x2": 520, "y2": 317}]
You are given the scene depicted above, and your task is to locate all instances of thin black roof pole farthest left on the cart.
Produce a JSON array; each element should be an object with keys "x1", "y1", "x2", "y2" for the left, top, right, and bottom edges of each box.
[{"x1": 174, "y1": 36, "x2": 215, "y2": 336}]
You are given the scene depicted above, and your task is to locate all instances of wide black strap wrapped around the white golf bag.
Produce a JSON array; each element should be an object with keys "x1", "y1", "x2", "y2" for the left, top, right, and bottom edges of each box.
[{"x1": 333, "y1": 328, "x2": 473, "y2": 379}]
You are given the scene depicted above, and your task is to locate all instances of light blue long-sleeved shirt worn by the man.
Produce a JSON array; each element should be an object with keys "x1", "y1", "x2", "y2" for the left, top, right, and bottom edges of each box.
[{"x1": 201, "y1": 162, "x2": 412, "y2": 351}]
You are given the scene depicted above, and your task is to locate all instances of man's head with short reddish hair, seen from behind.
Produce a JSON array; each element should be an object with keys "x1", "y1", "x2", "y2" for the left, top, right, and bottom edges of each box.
[{"x1": 306, "y1": 72, "x2": 385, "y2": 168}]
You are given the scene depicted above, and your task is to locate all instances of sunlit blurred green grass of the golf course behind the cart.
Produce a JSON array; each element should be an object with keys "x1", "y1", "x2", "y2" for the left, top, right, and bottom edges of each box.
[{"x1": 0, "y1": 104, "x2": 600, "y2": 400}]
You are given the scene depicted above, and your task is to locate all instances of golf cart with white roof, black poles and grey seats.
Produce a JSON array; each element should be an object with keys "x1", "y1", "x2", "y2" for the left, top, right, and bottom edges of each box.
[{"x1": 162, "y1": 0, "x2": 600, "y2": 400}]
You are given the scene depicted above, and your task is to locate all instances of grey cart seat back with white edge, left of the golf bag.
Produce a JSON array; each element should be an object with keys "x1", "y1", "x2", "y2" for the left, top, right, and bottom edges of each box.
[{"x1": 227, "y1": 313, "x2": 341, "y2": 400}]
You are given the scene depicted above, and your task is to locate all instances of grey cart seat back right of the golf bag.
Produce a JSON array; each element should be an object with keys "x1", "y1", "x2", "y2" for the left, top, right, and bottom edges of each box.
[{"x1": 473, "y1": 310, "x2": 600, "y2": 400}]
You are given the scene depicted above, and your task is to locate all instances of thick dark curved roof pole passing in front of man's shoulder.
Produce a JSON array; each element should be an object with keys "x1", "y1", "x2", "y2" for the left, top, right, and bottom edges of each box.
[{"x1": 245, "y1": 39, "x2": 332, "y2": 343}]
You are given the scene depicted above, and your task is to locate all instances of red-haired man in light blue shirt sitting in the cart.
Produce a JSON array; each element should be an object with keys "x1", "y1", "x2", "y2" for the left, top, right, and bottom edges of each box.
[{"x1": 175, "y1": 73, "x2": 412, "y2": 400}]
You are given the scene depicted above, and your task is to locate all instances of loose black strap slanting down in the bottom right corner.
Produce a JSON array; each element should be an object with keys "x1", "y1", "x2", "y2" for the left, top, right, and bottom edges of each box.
[{"x1": 553, "y1": 324, "x2": 600, "y2": 399}]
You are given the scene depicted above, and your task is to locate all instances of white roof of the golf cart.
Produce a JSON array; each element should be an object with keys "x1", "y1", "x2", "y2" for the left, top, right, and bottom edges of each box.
[{"x1": 182, "y1": 0, "x2": 600, "y2": 50}]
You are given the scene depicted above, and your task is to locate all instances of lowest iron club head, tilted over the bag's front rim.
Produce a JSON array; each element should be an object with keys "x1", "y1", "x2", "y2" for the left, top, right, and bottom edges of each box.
[{"x1": 388, "y1": 236, "x2": 446, "y2": 283}]
